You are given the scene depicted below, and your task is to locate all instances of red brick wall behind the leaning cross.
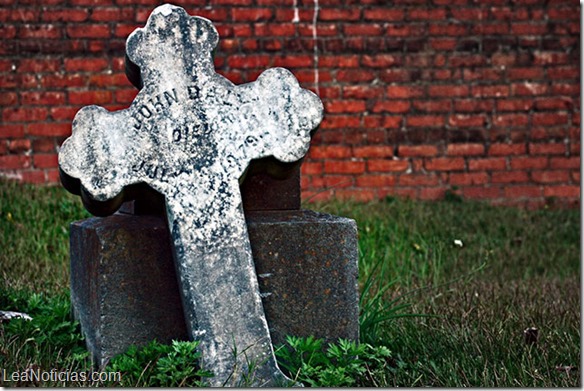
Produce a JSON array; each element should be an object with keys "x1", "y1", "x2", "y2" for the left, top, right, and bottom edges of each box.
[{"x1": 0, "y1": 0, "x2": 580, "y2": 206}]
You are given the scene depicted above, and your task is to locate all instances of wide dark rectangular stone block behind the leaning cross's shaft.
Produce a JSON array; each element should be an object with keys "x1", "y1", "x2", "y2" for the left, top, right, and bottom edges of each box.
[{"x1": 71, "y1": 210, "x2": 359, "y2": 365}]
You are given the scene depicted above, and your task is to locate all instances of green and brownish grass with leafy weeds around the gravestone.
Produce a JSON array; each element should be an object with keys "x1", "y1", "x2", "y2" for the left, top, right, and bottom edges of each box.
[{"x1": 0, "y1": 182, "x2": 581, "y2": 387}]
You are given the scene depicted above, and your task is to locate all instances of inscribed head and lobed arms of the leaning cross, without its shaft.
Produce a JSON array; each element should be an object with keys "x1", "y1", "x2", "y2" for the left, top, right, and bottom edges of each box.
[{"x1": 59, "y1": 4, "x2": 323, "y2": 214}]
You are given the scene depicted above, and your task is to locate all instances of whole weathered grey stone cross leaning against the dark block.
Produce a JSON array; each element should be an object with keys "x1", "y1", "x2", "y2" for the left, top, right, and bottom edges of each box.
[{"x1": 59, "y1": 4, "x2": 323, "y2": 386}]
